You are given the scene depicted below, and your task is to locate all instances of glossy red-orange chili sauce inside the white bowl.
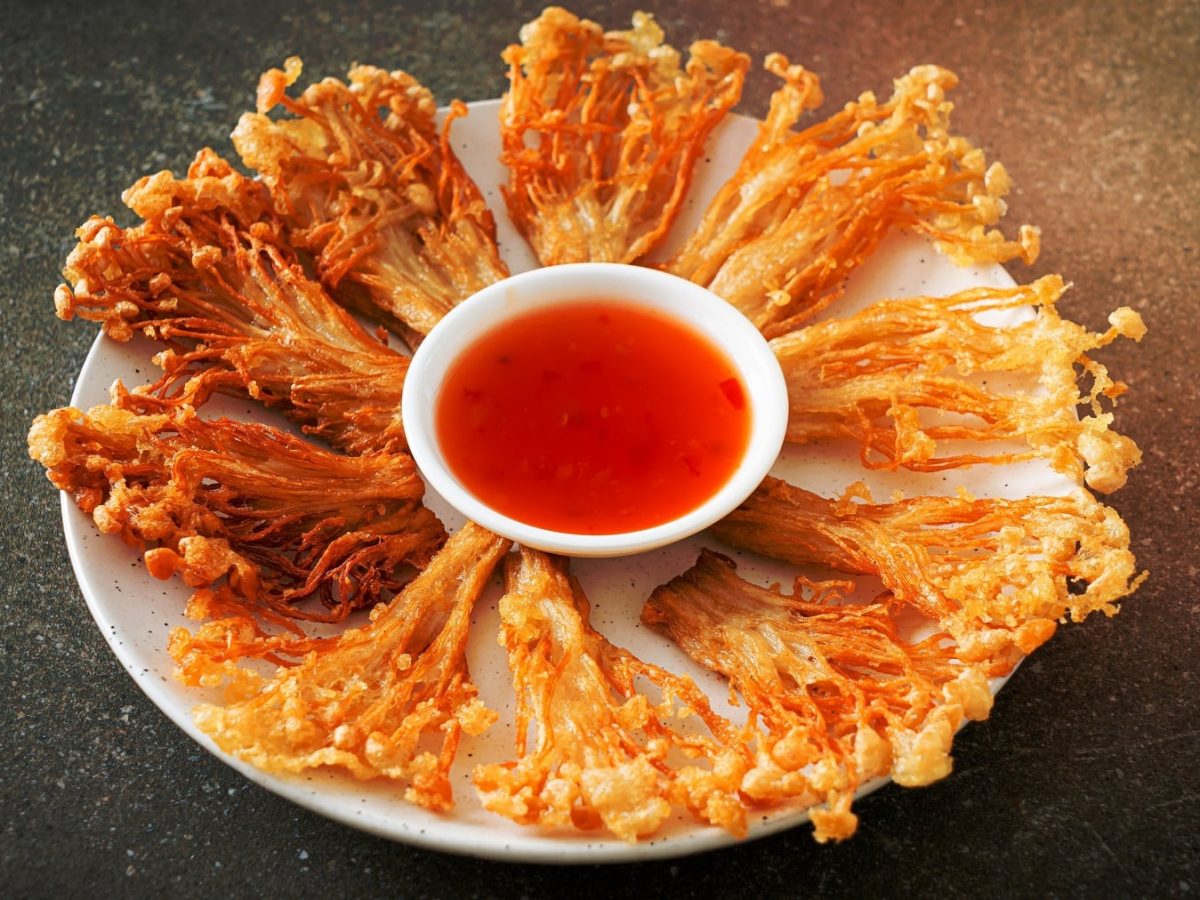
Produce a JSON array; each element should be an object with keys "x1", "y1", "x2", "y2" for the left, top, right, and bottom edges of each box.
[{"x1": 436, "y1": 300, "x2": 750, "y2": 534}]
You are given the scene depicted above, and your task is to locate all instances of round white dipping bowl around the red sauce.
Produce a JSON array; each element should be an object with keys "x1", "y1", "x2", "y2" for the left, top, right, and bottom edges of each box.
[{"x1": 401, "y1": 263, "x2": 787, "y2": 557}]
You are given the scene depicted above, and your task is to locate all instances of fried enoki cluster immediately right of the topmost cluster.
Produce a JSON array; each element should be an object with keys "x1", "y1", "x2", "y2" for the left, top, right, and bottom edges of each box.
[{"x1": 664, "y1": 53, "x2": 1038, "y2": 337}]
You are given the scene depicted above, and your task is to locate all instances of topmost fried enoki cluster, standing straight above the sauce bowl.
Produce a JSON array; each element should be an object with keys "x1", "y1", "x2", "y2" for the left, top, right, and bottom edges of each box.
[{"x1": 500, "y1": 7, "x2": 749, "y2": 265}]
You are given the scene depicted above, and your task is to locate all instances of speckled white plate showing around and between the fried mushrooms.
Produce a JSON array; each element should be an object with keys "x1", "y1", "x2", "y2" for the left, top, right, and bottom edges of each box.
[{"x1": 62, "y1": 101, "x2": 1072, "y2": 863}]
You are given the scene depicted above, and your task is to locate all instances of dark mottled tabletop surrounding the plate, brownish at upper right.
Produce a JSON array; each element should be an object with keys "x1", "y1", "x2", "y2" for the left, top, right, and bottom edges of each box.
[{"x1": 0, "y1": 0, "x2": 1200, "y2": 896}]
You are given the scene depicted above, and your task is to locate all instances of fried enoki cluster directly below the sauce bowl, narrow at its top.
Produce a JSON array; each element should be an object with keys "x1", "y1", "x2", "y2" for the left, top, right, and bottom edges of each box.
[{"x1": 473, "y1": 548, "x2": 748, "y2": 841}]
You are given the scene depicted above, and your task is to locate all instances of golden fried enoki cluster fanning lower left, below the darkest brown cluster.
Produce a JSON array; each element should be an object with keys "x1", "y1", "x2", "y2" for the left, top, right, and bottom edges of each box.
[{"x1": 194, "y1": 523, "x2": 509, "y2": 810}]
